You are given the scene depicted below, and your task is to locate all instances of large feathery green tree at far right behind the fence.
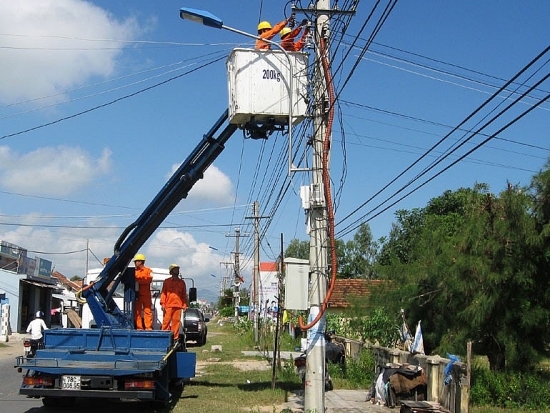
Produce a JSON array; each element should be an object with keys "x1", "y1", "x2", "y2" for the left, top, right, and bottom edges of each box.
[{"x1": 381, "y1": 182, "x2": 550, "y2": 370}]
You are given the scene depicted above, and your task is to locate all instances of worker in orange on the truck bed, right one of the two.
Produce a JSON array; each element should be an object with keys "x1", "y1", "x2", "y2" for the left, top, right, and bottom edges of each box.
[{"x1": 160, "y1": 264, "x2": 187, "y2": 340}]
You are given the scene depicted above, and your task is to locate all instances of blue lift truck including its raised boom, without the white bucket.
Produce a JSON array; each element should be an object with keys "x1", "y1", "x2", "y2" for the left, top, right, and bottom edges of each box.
[{"x1": 15, "y1": 110, "x2": 238, "y2": 406}]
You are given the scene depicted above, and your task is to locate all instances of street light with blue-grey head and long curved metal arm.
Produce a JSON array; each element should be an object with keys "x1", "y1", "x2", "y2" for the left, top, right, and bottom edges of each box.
[{"x1": 180, "y1": 7, "x2": 294, "y2": 175}]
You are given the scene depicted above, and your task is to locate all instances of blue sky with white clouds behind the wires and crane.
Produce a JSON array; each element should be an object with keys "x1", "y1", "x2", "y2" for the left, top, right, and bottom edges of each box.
[{"x1": 0, "y1": 0, "x2": 550, "y2": 299}]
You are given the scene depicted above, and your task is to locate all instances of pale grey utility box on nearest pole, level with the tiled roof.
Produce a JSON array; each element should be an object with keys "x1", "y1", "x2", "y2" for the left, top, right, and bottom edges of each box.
[{"x1": 285, "y1": 258, "x2": 309, "y2": 310}]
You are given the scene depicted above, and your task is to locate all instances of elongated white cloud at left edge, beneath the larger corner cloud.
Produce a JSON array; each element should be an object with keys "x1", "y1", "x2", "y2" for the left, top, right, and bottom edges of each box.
[{"x1": 0, "y1": 146, "x2": 111, "y2": 195}]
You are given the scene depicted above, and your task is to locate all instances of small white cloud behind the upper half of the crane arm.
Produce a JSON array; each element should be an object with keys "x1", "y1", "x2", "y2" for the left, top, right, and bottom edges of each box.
[{"x1": 167, "y1": 164, "x2": 235, "y2": 205}]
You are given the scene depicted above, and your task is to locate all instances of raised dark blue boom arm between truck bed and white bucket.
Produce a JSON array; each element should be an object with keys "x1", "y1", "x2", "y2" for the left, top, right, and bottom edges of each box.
[{"x1": 82, "y1": 110, "x2": 238, "y2": 327}]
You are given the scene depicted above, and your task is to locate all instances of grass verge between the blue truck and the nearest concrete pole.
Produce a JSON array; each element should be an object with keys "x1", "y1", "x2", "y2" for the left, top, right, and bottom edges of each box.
[{"x1": 170, "y1": 323, "x2": 300, "y2": 413}]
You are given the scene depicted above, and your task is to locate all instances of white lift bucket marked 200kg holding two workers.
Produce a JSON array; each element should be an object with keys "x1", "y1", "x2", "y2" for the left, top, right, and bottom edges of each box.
[{"x1": 227, "y1": 48, "x2": 308, "y2": 125}]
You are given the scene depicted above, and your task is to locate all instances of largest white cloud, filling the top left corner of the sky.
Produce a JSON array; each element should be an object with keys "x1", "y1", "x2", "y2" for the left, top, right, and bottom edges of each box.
[{"x1": 0, "y1": 0, "x2": 144, "y2": 103}]
